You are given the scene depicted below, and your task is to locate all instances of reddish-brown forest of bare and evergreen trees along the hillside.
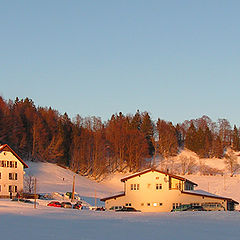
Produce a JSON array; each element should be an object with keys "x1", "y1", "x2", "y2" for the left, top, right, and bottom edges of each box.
[{"x1": 0, "y1": 97, "x2": 240, "y2": 179}]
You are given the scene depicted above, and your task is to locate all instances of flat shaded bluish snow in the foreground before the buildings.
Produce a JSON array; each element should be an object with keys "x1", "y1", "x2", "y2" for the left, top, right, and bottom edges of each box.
[{"x1": 0, "y1": 200, "x2": 240, "y2": 240}]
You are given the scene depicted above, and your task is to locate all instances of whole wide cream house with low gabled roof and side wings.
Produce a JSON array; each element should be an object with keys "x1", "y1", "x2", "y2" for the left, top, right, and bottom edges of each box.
[{"x1": 101, "y1": 169, "x2": 238, "y2": 212}]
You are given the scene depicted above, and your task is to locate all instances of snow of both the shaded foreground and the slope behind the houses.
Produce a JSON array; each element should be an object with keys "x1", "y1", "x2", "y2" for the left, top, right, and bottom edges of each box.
[{"x1": 0, "y1": 157, "x2": 240, "y2": 240}]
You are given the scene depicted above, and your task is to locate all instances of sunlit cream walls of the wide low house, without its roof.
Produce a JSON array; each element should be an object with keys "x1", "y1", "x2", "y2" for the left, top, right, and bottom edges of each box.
[{"x1": 105, "y1": 172, "x2": 227, "y2": 212}]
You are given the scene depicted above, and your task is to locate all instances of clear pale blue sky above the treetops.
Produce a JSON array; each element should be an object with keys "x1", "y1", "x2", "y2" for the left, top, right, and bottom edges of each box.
[{"x1": 0, "y1": 0, "x2": 240, "y2": 126}]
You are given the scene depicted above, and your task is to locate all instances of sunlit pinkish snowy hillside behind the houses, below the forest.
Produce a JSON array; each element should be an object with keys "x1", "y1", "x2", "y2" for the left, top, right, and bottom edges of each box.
[{"x1": 23, "y1": 151, "x2": 240, "y2": 208}]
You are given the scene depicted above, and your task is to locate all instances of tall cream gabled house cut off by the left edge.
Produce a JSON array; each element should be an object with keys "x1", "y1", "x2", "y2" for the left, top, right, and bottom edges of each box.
[{"x1": 0, "y1": 144, "x2": 28, "y2": 198}]
